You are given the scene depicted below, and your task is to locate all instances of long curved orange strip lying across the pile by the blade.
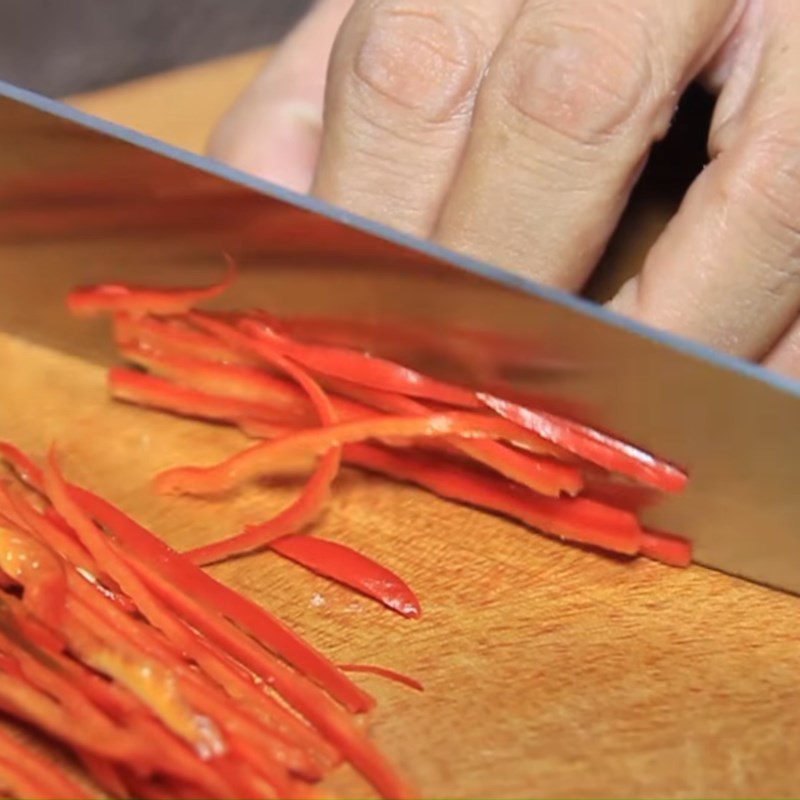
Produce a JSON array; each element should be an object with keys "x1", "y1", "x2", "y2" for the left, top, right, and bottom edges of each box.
[{"x1": 155, "y1": 411, "x2": 549, "y2": 494}]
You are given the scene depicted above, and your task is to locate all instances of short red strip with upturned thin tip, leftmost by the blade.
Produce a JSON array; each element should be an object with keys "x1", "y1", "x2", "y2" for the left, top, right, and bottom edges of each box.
[{"x1": 67, "y1": 256, "x2": 238, "y2": 317}]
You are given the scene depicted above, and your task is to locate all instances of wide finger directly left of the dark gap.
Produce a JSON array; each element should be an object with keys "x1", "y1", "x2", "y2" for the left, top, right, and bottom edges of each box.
[{"x1": 435, "y1": 0, "x2": 736, "y2": 289}]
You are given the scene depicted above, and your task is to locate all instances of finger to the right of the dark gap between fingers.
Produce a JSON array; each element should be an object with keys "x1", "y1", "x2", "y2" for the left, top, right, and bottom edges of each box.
[{"x1": 612, "y1": 0, "x2": 800, "y2": 359}]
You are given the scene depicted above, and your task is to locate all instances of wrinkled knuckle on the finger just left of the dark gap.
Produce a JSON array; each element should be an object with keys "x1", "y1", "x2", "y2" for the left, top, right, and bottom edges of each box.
[{"x1": 499, "y1": 5, "x2": 651, "y2": 146}]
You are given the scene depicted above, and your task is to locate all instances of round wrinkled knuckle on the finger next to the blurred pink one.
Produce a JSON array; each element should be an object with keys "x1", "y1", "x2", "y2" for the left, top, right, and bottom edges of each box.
[{"x1": 351, "y1": 0, "x2": 489, "y2": 122}]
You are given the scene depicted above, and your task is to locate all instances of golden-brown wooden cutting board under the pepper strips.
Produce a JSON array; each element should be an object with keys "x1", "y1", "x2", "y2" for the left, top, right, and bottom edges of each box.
[{"x1": 0, "y1": 54, "x2": 800, "y2": 797}]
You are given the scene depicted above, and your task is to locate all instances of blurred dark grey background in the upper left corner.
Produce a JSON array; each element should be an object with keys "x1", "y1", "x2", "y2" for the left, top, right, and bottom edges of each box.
[{"x1": 0, "y1": 0, "x2": 311, "y2": 96}]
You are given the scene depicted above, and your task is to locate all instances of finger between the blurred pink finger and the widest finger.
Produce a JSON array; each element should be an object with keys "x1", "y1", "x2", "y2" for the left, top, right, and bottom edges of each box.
[{"x1": 314, "y1": 0, "x2": 520, "y2": 235}]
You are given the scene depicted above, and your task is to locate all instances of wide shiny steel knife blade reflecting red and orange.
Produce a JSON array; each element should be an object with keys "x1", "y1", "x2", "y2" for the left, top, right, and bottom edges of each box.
[{"x1": 0, "y1": 83, "x2": 800, "y2": 593}]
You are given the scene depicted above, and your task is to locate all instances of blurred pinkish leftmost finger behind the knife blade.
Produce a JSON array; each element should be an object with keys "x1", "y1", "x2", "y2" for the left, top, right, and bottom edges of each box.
[{"x1": 208, "y1": 0, "x2": 352, "y2": 191}]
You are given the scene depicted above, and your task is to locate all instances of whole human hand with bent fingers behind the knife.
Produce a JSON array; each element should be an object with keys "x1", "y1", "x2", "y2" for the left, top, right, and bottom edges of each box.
[{"x1": 211, "y1": 0, "x2": 800, "y2": 378}]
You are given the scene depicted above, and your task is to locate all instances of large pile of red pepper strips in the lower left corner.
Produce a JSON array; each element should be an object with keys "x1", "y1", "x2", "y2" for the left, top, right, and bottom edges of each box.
[{"x1": 0, "y1": 444, "x2": 412, "y2": 798}]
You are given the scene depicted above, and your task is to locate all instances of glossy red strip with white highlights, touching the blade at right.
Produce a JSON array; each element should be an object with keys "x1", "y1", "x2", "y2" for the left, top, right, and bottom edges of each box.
[{"x1": 477, "y1": 393, "x2": 687, "y2": 492}]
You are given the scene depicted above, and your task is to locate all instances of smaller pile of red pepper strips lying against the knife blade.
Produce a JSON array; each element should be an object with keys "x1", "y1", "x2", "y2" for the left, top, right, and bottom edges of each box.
[{"x1": 68, "y1": 259, "x2": 691, "y2": 576}]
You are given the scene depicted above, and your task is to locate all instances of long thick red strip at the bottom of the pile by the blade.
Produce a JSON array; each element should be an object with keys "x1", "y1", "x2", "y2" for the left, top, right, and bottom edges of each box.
[{"x1": 345, "y1": 444, "x2": 642, "y2": 555}]
